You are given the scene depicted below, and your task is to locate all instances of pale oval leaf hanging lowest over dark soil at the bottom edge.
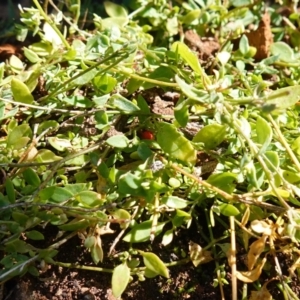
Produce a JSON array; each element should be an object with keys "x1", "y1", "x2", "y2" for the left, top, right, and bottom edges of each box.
[{"x1": 111, "y1": 263, "x2": 130, "y2": 298}]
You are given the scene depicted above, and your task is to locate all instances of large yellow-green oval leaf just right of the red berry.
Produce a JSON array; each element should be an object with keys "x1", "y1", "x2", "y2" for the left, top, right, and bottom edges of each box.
[{"x1": 157, "y1": 122, "x2": 197, "y2": 164}]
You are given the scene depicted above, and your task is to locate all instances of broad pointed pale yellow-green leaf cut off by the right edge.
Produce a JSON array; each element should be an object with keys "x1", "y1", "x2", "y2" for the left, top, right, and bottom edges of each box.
[{"x1": 262, "y1": 85, "x2": 300, "y2": 110}]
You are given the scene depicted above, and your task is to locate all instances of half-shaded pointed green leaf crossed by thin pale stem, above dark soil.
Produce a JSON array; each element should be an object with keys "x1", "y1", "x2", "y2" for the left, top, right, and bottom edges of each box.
[{"x1": 123, "y1": 220, "x2": 167, "y2": 243}]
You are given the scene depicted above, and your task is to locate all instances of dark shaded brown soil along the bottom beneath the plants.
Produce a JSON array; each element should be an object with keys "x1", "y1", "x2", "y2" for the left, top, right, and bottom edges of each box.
[{"x1": 3, "y1": 219, "x2": 230, "y2": 300}]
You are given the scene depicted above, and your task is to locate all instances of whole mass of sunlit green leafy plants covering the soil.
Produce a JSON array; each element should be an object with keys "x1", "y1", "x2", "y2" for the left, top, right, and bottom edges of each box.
[{"x1": 0, "y1": 0, "x2": 300, "y2": 299}]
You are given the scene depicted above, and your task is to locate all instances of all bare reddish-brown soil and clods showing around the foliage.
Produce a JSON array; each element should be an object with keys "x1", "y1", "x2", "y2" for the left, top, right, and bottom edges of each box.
[{"x1": 0, "y1": 0, "x2": 299, "y2": 300}]
